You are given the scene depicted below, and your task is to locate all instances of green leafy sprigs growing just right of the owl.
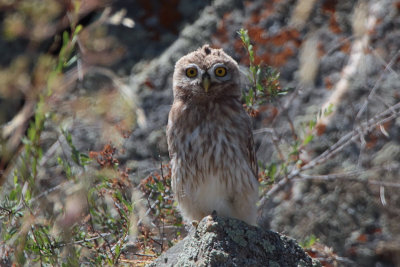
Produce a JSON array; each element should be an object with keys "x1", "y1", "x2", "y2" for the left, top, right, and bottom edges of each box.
[{"x1": 238, "y1": 29, "x2": 340, "y2": 195}]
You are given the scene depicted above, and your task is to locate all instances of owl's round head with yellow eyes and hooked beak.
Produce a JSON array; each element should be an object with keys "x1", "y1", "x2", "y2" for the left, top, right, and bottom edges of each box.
[{"x1": 173, "y1": 45, "x2": 241, "y2": 101}]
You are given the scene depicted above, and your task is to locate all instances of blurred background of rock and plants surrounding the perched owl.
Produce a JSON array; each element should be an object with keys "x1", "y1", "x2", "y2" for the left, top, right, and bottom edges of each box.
[{"x1": 0, "y1": 0, "x2": 400, "y2": 266}]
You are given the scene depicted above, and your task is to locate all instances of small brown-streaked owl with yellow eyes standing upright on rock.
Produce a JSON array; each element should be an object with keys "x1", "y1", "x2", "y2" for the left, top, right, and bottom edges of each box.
[{"x1": 167, "y1": 45, "x2": 258, "y2": 225}]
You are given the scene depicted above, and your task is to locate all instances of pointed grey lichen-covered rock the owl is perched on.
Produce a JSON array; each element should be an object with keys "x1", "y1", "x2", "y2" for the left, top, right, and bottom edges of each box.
[{"x1": 148, "y1": 215, "x2": 321, "y2": 267}]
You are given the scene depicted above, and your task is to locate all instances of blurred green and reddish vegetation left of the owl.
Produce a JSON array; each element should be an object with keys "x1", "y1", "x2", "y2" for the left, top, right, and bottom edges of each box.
[{"x1": 0, "y1": 1, "x2": 180, "y2": 266}]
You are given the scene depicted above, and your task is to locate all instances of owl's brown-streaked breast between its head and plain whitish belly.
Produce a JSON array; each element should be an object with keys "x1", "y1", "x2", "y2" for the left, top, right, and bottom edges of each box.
[{"x1": 168, "y1": 102, "x2": 255, "y2": 199}]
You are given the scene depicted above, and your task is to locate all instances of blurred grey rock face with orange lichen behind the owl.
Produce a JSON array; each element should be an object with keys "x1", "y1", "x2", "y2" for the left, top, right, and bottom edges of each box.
[{"x1": 0, "y1": 0, "x2": 400, "y2": 266}]
